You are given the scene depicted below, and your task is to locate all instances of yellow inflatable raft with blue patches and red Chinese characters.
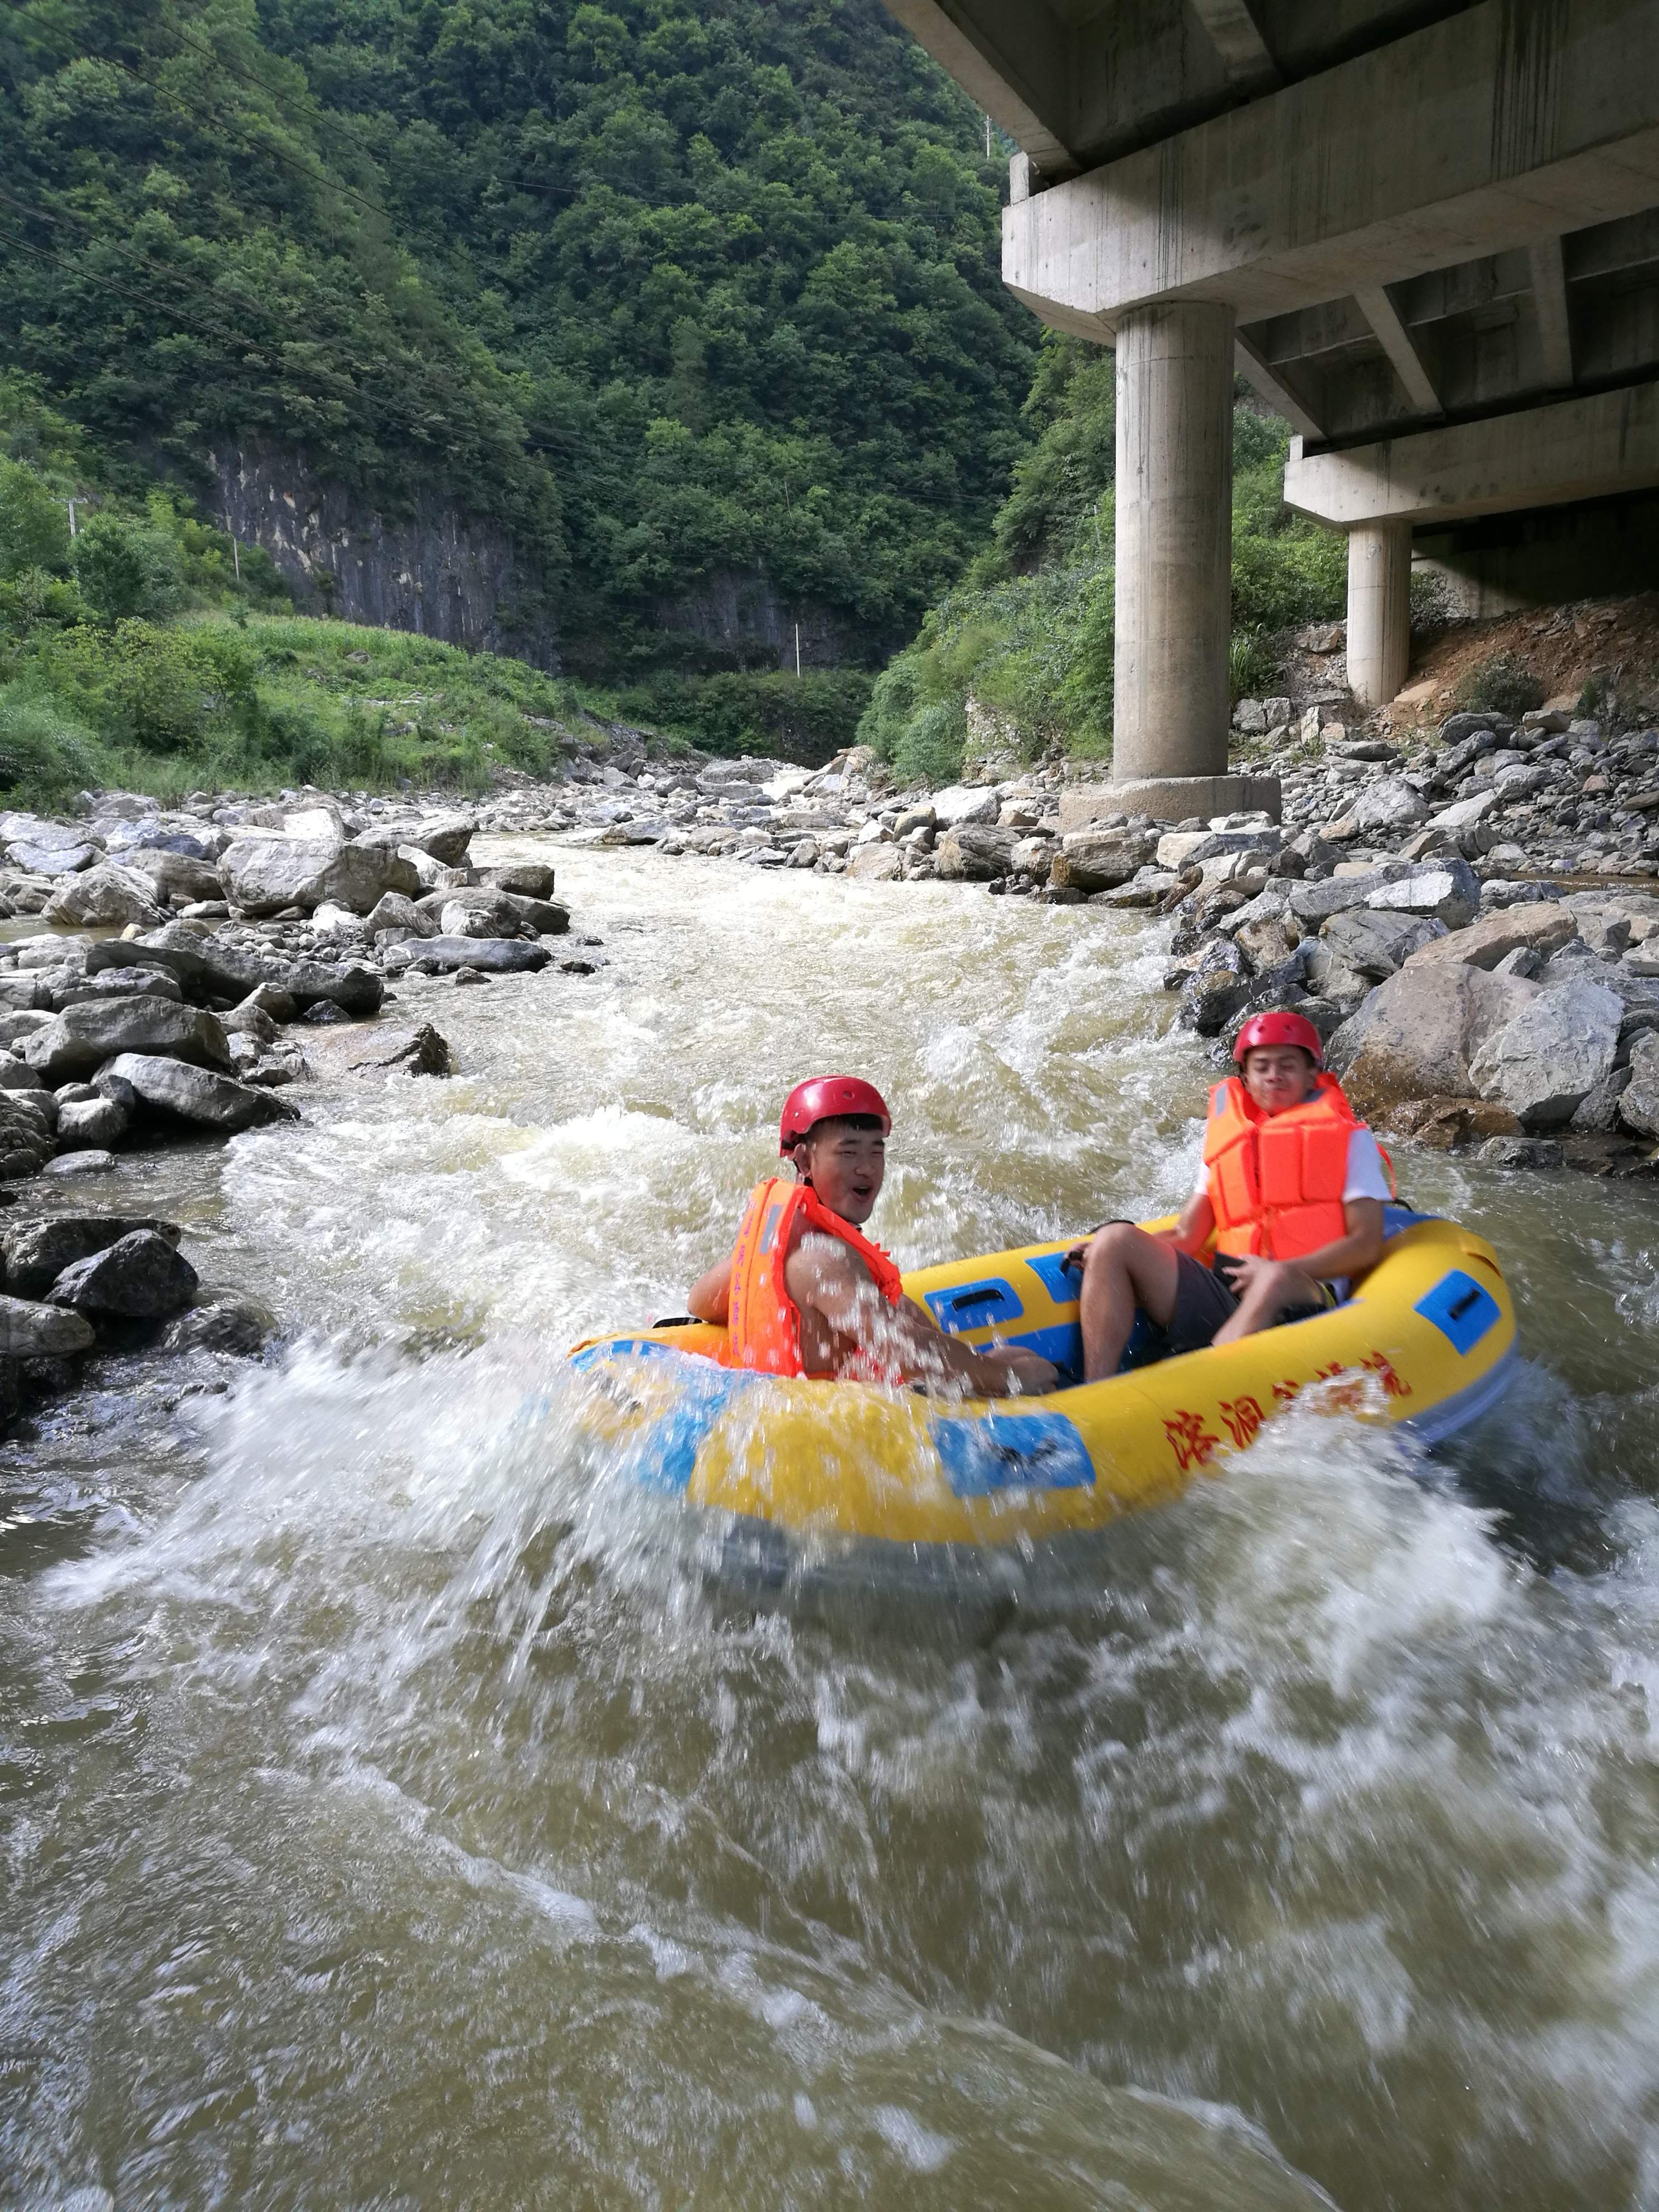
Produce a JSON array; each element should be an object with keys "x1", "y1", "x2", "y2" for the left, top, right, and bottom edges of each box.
[{"x1": 571, "y1": 1206, "x2": 1515, "y2": 1549}]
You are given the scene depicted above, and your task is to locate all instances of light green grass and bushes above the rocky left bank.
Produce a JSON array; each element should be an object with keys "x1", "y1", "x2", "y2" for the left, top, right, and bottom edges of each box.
[{"x1": 0, "y1": 379, "x2": 641, "y2": 809}]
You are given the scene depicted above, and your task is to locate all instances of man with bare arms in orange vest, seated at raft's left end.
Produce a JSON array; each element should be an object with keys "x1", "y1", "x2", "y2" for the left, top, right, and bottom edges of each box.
[{"x1": 686, "y1": 1075, "x2": 1060, "y2": 1398}]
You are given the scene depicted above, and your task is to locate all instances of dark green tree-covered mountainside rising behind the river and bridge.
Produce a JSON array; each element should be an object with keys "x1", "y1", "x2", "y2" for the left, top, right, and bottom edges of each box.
[{"x1": 0, "y1": 0, "x2": 1037, "y2": 734}]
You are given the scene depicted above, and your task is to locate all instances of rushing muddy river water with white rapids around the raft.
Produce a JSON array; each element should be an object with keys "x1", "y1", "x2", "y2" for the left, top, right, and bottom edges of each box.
[{"x1": 0, "y1": 841, "x2": 1659, "y2": 2212}]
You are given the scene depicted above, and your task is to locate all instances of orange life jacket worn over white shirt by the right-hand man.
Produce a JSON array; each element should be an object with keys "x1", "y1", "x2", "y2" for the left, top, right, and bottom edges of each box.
[{"x1": 1204, "y1": 1075, "x2": 1394, "y2": 1259}]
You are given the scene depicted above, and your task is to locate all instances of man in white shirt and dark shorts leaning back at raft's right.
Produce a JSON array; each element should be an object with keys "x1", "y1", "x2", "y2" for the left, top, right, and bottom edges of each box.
[{"x1": 1069, "y1": 1013, "x2": 1391, "y2": 1382}]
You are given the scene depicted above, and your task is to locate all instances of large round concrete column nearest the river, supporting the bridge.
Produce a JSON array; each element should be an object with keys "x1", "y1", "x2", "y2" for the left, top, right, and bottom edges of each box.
[{"x1": 1113, "y1": 301, "x2": 1232, "y2": 796}]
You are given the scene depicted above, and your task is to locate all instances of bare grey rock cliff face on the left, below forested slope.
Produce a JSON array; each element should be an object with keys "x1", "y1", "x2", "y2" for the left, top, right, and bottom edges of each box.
[{"x1": 212, "y1": 447, "x2": 560, "y2": 672}]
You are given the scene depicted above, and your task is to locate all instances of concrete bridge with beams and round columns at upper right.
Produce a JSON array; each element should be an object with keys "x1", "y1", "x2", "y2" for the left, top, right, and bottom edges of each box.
[{"x1": 887, "y1": 0, "x2": 1659, "y2": 816}]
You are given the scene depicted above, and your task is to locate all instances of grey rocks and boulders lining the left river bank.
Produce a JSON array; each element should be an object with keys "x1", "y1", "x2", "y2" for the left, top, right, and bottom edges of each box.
[{"x1": 0, "y1": 792, "x2": 604, "y2": 1427}]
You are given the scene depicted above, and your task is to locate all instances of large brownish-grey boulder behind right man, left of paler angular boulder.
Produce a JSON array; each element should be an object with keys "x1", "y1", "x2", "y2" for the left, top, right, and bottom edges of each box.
[{"x1": 1325, "y1": 962, "x2": 1537, "y2": 1113}]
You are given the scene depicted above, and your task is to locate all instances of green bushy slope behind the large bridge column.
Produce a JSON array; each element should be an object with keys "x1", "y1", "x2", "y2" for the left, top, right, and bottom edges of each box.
[{"x1": 858, "y1": 334, "x2": 1347, "y2": 781}]
